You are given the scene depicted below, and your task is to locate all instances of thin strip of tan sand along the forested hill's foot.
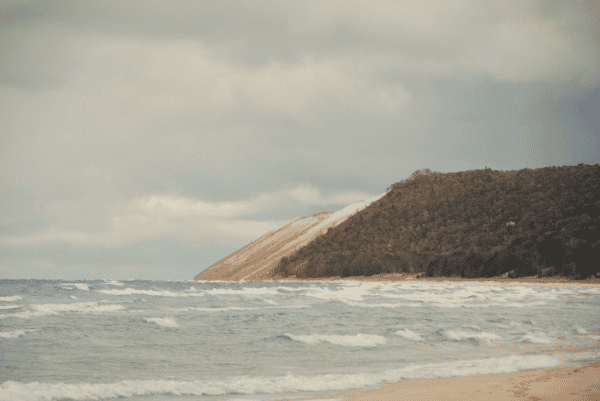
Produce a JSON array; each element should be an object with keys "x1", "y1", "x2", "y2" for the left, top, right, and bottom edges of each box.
[{"x1": 270, "y1": 273, "x2": 600, "y2": 288}]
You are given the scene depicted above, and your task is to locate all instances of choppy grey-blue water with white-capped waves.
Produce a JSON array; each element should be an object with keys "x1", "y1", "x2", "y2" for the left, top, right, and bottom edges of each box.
[{"x1": 0, "y1": 280, "x2": 600, "y2": 401}]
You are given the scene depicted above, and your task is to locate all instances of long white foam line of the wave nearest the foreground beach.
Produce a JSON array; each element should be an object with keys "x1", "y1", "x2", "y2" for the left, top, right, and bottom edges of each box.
[{"x1": 0, "y1": 355, "x2": 560, "y2": 401}]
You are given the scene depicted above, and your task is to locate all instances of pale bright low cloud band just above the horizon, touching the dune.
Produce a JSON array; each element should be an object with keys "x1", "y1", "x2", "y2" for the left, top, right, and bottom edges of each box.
[{"x1": 0, "y1": 186, "x2": 372, "y2": 249}]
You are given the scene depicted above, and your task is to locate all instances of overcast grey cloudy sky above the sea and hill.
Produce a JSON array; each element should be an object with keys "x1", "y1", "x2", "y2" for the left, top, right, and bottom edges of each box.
[{"x1": 0, "y1": 0, "x2": 600, "y2": 280}]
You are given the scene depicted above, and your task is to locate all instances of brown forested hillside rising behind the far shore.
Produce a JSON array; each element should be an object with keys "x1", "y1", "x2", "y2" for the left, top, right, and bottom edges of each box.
[{"x1": 275, "y1": 164, "x2": 600, "y2": 278}]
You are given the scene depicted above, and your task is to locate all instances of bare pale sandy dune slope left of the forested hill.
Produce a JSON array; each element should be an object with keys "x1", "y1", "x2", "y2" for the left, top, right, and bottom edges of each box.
[{"x1": 194, "y1": 193, "x2": 385, "y2": 280}]
